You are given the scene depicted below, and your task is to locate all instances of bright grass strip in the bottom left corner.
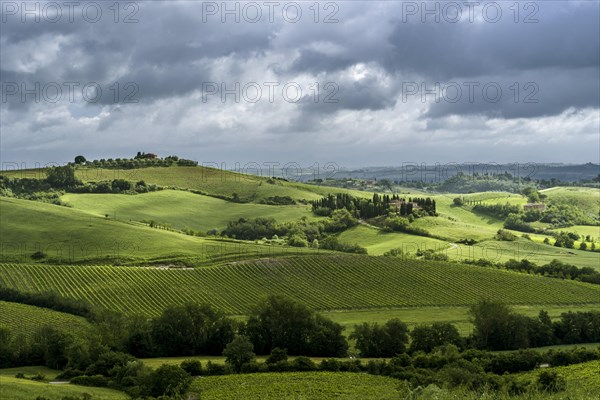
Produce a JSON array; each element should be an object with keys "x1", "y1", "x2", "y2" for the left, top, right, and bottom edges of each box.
[{"x1": 0, "y1": 376, "x2": 129, "y2": 400}]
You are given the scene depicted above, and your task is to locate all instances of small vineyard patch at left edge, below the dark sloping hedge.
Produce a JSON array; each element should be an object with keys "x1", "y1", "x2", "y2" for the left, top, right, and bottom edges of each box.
[{"x1": 0, "y1": 301, "x2": 91, "y2": 337}]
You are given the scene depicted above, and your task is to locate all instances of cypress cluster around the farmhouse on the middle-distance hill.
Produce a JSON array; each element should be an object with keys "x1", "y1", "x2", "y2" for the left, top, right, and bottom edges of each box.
[{"x1": 312, "y1": 193, "x2": 436, "y2": 219}]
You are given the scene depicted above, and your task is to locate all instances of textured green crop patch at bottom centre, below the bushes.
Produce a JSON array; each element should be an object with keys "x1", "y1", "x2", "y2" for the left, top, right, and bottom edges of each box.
[{"x1": 191, "y1": 372, "x2": 399, "y2": 400}]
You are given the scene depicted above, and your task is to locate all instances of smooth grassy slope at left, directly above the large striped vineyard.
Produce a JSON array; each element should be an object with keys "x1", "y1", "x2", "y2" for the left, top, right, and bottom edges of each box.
[{"x1": 0, "y1": 197, "x2": 310, "y2": 265}]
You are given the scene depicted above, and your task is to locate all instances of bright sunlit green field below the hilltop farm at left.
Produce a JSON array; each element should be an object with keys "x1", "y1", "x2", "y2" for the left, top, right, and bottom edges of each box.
[{"x1": 61, "y1": 190, "x2": 313, "y2": 232}]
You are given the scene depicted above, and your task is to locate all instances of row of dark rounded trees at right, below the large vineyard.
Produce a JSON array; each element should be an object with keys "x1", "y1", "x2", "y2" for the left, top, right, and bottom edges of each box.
[{"x1": 350, "y1": 300, "x2": 600, "y2": 357}]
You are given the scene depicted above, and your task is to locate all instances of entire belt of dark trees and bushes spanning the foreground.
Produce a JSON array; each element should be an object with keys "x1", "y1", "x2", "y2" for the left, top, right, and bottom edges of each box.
[{"x1": 0, "y1": 296, "x2": 600, "y2": 398}]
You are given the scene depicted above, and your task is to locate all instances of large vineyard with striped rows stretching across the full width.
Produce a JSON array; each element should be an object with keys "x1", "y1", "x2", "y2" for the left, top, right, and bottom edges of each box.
[{"x1": 0, "y1": 255, "x2": 600, "y2": 315}]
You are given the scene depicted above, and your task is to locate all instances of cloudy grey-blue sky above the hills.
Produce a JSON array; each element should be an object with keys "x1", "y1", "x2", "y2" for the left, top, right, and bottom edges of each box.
[{"x1": 0, "y1": 0, "x2": 600, "y2": 169}]
